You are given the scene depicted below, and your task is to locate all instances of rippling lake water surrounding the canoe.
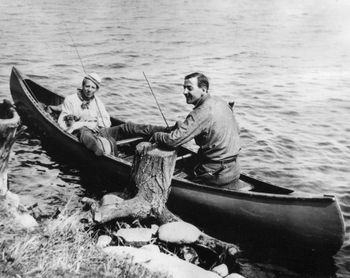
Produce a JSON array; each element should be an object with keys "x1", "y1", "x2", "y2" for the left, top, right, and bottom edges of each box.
[{"x1": 0, "y1": 0, "x2": 350, "y2": 277}]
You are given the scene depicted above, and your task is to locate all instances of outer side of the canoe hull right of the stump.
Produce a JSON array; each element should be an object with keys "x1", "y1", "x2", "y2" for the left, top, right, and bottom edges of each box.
[{"x1": 168, "y1": 181, "x2": 344, "y2": 254}]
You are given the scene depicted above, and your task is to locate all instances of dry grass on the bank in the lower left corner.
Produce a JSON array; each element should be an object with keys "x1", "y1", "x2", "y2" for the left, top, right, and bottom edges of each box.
[{"x1": 0, "y1": 199, "x2": 168, "y2": 278}]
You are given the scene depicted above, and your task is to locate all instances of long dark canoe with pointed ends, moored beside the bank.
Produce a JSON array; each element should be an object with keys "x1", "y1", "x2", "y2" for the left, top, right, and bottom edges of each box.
[{"x1": 10, "y1": 67, "x2": 345, "y2": 255}]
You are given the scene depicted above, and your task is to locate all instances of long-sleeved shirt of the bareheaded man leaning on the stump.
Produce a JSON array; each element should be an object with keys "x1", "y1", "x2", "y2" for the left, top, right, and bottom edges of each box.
[{"x1": 155, "y1": 94, "x2": 240, "y2": 163}]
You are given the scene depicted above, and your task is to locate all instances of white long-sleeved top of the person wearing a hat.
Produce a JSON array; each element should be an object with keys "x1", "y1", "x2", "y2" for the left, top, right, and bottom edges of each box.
[{"x1": 58, "y1": 93, "x2": 111, "y2": 132}]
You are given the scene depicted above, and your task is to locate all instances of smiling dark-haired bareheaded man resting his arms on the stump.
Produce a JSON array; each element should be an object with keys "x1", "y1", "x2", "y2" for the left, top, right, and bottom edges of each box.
[{"x1": 151, "y1": 73, "x2": 240, "y2": 187}]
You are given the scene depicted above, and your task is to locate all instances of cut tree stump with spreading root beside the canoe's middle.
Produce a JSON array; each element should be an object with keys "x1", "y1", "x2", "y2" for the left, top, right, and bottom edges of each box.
[{"x1": 93, "y1": 142, "x2": 178, "y2": 223}]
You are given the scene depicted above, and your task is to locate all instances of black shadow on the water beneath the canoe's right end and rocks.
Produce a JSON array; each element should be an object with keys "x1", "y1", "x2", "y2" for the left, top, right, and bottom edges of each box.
[{"x1": 191, "y1": 220, "x2": 337, "y2": 278}]
